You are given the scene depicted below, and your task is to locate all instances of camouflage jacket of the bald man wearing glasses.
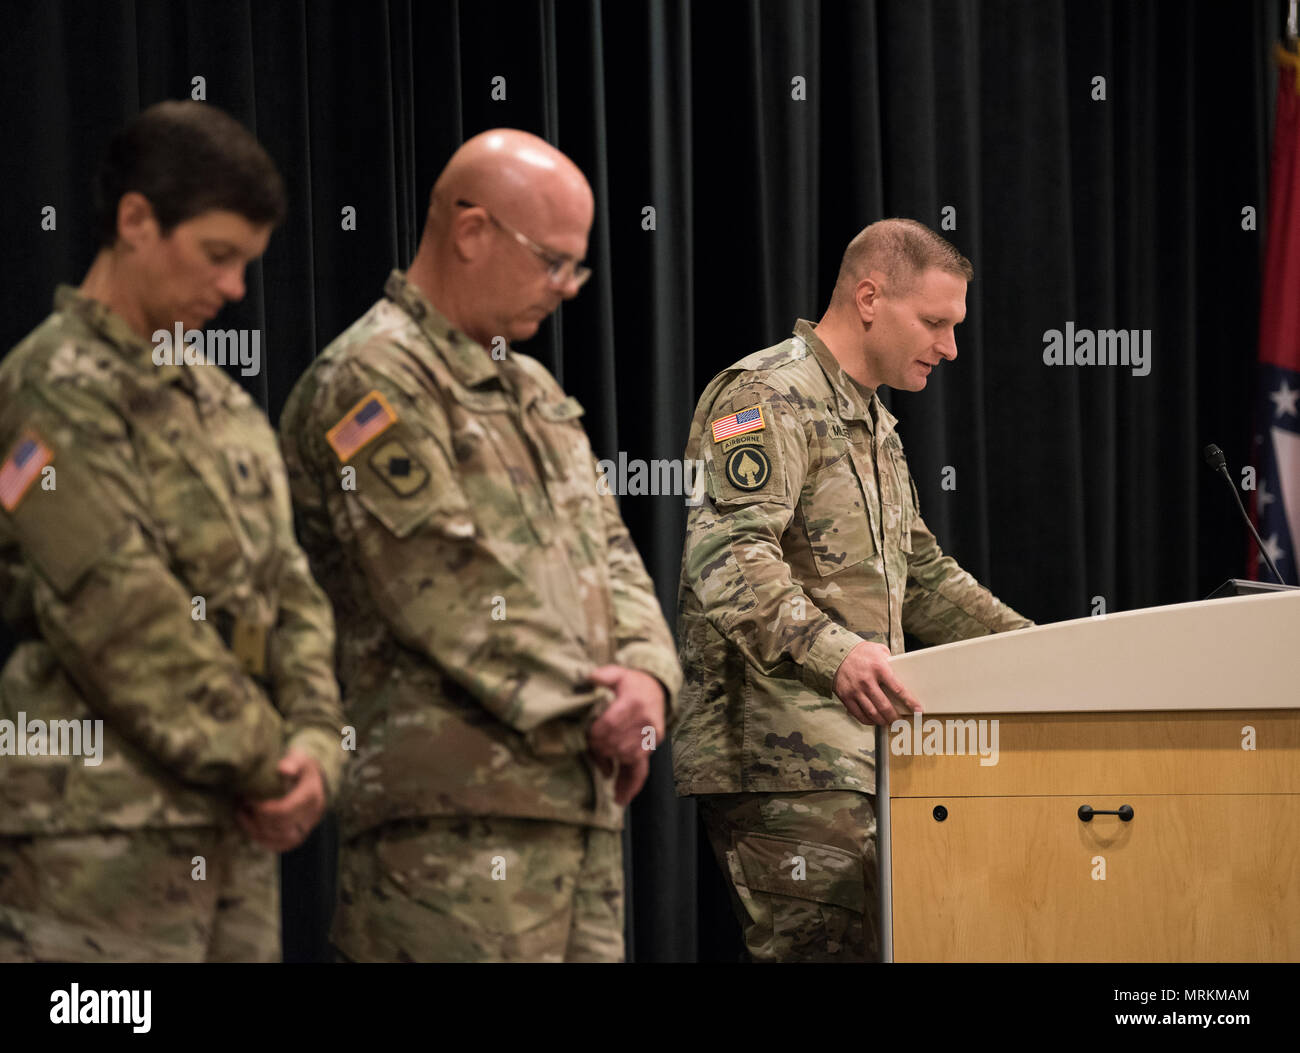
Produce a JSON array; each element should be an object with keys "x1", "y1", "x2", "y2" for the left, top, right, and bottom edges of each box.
[{"x1": 281, "y1": 272, "x2": 681, "y2": 836}]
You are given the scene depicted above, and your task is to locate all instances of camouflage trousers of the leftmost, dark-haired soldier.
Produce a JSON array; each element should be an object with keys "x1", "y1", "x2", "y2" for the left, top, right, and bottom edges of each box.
[{"x1": 0, "y1": 827, "x2": 280, "y2": 962}]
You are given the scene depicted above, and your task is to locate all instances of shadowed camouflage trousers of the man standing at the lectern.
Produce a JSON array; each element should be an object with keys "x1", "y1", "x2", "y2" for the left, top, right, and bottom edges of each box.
[{"x1": 699, "y1": 790, "x2": 880, "y2": 962}]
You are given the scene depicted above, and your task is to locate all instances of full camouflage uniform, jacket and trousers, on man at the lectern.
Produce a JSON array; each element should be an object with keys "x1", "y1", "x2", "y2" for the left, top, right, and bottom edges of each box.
[{"x1": 673, "y1": 320, "x2": 1031, "y2": 961}]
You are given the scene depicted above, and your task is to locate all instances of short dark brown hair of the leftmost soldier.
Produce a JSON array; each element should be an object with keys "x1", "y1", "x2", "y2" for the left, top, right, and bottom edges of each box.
[{"x1": 95, "y1": 100, "x2": 285, "y2": 248}]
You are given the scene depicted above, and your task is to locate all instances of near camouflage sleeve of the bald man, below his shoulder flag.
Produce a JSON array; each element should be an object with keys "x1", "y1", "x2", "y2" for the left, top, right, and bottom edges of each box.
[{"x1": 297, "y1": 363, "x2": 608, "y2": 728}]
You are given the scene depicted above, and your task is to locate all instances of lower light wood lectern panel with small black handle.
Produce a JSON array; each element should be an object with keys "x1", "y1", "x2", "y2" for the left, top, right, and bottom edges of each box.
[{"x1": 891, "y1": 790, "x2": 1300, "y2": 962}]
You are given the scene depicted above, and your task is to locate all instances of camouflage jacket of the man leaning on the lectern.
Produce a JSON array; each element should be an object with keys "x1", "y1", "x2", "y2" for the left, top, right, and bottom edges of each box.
[{"x1": 672, "y1": 320, "x2": 1031, "y2": 794}]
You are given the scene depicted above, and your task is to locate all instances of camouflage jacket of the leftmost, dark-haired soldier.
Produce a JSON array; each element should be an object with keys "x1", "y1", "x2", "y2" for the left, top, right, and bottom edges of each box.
[{"x1": 0, "y1": 286, "x2": 343, "y2": 833}]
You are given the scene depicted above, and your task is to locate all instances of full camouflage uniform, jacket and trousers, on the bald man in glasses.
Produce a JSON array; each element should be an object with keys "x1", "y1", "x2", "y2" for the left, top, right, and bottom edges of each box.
[{"x1": 281, "y1": 272, "x2": 681, "y2": 961}]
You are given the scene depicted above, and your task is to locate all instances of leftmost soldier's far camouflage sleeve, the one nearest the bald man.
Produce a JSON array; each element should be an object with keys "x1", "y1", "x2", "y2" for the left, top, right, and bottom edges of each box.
[{"x1": 262, "y1": 431, "x2": 343, "y2": 801}]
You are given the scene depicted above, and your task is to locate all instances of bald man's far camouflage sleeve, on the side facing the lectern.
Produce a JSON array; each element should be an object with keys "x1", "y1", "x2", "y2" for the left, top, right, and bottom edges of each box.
[{"x1": 601, "y1": 494, "x2": 681, "y2": 723}]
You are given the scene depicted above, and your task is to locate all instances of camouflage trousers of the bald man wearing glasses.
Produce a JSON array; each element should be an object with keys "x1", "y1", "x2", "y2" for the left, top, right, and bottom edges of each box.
[{"x1": 332, "y1": 816, "x2": 623, "y2": 962}]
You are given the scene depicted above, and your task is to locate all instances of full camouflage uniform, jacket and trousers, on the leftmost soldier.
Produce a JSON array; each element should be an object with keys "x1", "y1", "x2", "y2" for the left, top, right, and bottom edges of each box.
[{"x1": 0, "y1": 287, "x2": 343, "y2": 961}]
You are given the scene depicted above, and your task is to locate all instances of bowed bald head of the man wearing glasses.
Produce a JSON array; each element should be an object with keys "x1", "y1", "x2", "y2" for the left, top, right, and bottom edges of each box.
[{"x1": 408, "y1": 129, "x2": 595, "y2": 347}]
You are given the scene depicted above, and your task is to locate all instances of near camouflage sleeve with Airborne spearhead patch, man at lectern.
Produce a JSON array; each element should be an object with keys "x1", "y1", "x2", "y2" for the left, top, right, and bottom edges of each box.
[{"x1": 683, "y1": 380, "x2": 863, "y2": 694}]
